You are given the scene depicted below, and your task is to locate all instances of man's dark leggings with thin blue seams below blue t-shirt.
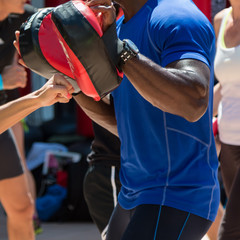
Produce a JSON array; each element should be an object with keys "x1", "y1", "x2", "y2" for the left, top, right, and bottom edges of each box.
[{"x1": 106, "y1": 204, "x2": 212, "y2": 240}]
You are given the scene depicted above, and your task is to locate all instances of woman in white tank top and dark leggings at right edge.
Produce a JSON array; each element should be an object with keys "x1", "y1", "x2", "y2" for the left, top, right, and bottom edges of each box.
[{"x1": 213, "y1": 0, "x2": 240, "y2": 240}]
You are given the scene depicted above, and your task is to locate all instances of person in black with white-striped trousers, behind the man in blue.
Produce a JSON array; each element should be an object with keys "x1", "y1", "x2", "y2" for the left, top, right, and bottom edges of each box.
[{"x1": 83, "y1": 122, "x2": 121, "y2": 240}]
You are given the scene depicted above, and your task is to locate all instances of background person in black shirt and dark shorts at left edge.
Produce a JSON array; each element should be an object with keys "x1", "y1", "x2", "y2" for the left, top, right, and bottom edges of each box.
[{"x1": 0, "y1": 0, "x2": 39, "y2": 240}]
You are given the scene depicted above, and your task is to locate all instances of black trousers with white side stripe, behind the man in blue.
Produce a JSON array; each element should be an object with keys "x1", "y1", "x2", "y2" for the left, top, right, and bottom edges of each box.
[{"x1": 83, "y1": 163, "x2": 121, "y2": 239}]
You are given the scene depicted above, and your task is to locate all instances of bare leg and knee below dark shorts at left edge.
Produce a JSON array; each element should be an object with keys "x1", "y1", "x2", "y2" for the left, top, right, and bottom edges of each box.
[{"x1": 0, "y1": 174, "x2": 35, "y2": 240}]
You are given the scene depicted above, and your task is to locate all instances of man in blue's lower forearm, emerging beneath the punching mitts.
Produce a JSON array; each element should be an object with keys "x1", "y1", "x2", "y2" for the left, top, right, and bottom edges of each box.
[{"x1": 74, "y1": 93, "x2": 118, "y2": 136}]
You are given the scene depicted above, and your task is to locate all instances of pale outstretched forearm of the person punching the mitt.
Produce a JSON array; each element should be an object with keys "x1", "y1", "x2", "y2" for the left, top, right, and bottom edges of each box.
[{"x1": 0, "y1": 94, "x2": 39, "y2": 133}]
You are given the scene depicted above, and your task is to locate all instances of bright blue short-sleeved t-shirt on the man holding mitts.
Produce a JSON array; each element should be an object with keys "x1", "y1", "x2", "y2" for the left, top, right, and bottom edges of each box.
[{"x1": 112, "y1": 0, "x2": 219, "y2": 220}]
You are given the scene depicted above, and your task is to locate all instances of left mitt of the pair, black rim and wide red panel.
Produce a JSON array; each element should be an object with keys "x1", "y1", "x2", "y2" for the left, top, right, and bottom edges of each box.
[{"x1": 19, "y1": 8, "x2": 80, "y2": 92}]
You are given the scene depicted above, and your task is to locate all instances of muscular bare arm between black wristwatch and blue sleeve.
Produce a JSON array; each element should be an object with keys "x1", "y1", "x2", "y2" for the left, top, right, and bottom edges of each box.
[{"x1": 123, "y1": 55, "x2": 209, "y2": 121}]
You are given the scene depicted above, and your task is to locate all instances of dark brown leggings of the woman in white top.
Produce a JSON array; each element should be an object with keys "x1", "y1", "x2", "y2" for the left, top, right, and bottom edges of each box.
[{"x1": 219, "y1": 143, "x2": 240, "y2": 240}]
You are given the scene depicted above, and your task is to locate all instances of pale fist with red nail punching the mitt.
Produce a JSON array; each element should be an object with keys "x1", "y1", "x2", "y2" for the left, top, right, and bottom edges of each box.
[{"x1": 34, "y1": 74, "x2": 74, "y2": 107}]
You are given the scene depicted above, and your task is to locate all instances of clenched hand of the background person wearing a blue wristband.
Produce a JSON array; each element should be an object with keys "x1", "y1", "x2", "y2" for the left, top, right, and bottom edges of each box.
[{"x1": 2, "y1": 53, "x2": 27, "y2": 89}]
